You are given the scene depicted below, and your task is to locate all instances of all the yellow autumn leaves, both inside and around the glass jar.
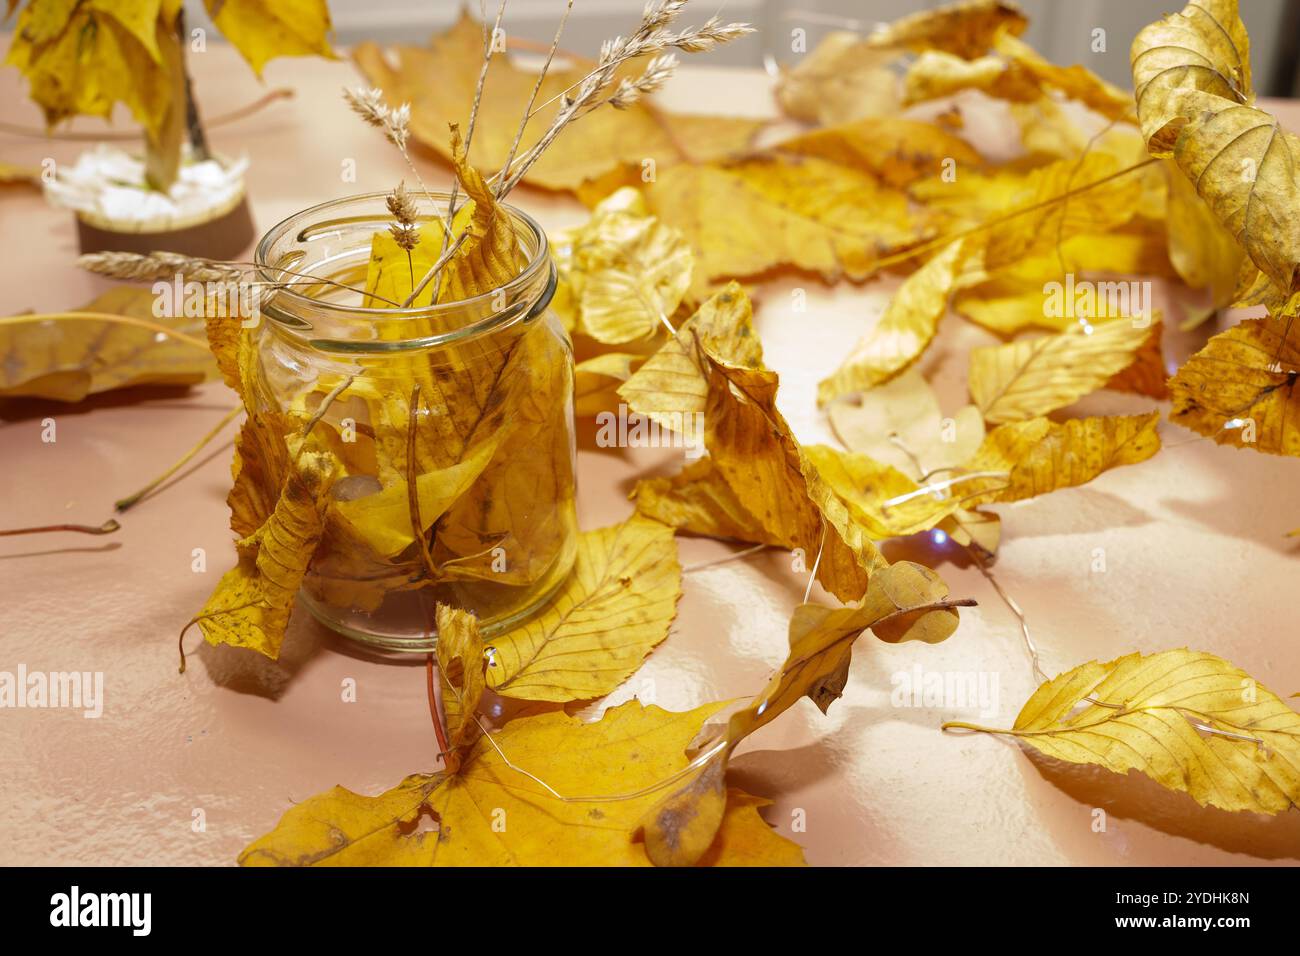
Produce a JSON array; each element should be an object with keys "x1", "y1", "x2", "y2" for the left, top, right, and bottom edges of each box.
[{"x1": 12, "y1": 0, "x2": 1300, "y2": 865}]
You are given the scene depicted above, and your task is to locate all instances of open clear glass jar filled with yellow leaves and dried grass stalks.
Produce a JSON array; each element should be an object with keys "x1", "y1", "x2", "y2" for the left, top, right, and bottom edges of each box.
[{"x1": 251, "y1": 193, "x2": 577, "y2": 652}]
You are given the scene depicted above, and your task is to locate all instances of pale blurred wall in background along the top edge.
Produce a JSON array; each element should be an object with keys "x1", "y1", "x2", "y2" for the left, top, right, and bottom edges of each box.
[{"x1": 180, "y1": 0, "x2": 1300, "y2": 91}]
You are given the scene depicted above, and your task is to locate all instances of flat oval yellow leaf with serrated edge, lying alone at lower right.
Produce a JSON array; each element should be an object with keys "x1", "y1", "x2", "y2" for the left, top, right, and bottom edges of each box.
[{"x1": 944, "y1": 648, "x2": 1300, "y2": 813}]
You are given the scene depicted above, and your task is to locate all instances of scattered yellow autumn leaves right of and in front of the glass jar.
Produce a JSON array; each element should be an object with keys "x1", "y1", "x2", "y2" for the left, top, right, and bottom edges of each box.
[{"x1": 243, "y1": 0, "x2": 1300, "y2": 865}]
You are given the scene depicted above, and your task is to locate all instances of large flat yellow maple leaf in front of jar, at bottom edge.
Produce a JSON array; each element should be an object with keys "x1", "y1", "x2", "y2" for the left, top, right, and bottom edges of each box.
[{"x1": 239, "y1": 701, "x2": 803, "y2": 866}]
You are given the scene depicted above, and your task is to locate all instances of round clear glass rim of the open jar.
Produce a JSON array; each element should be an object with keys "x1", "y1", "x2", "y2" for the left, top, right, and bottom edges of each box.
[{"x1": 254, "y1": 190, "x2": 554, "y2": 330}]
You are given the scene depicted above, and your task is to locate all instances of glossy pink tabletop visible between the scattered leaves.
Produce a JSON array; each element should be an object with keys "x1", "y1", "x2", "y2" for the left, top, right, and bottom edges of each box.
[{"x1": 0, "y1": 47, "x2": 1300, "y2": 865}]
